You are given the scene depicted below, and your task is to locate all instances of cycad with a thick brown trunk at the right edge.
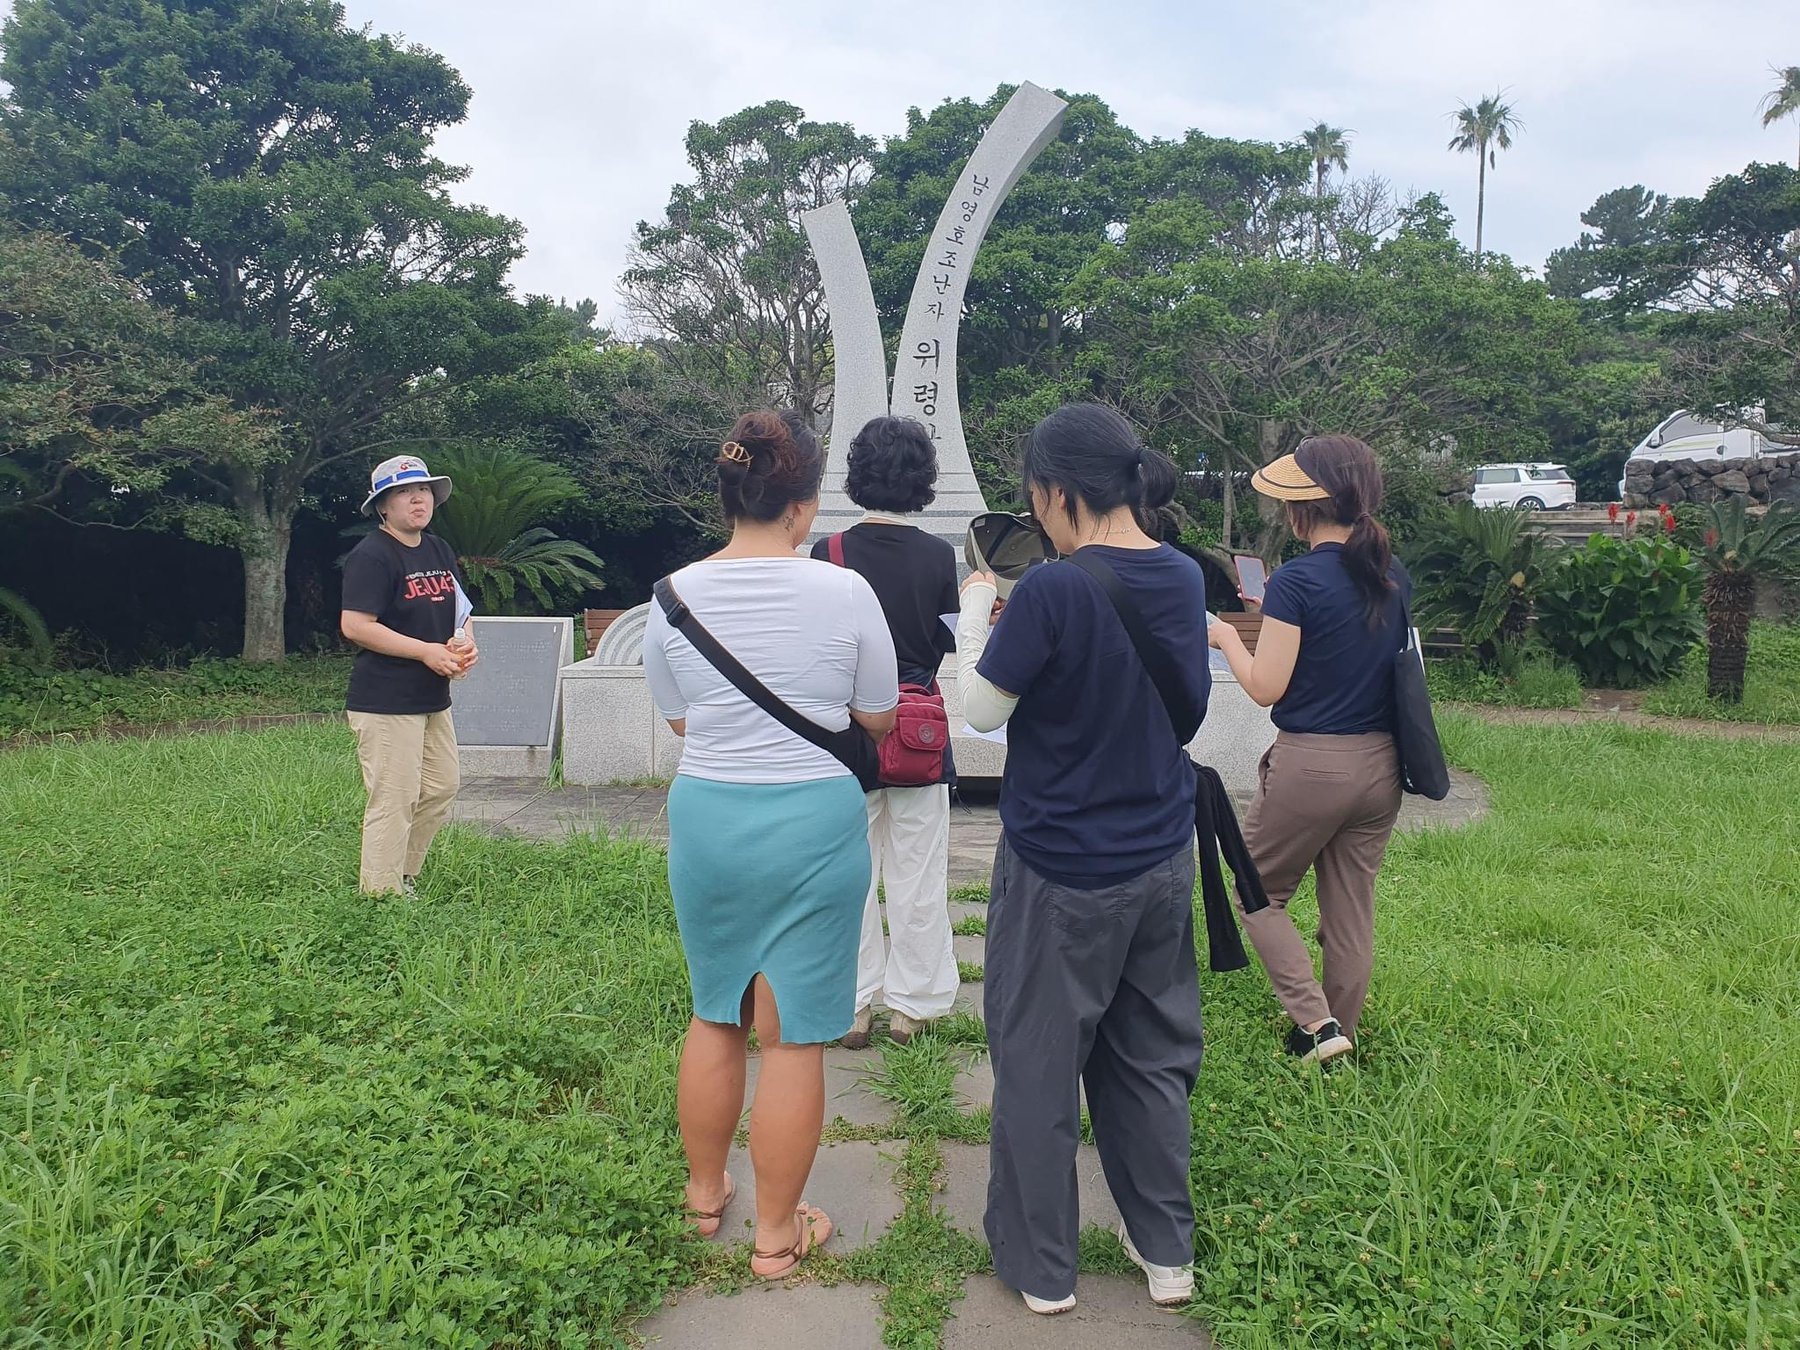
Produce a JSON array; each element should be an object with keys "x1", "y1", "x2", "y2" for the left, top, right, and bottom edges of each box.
[{"x1": 1690, "y1": 497, "x2": 1800, "y2": 704}]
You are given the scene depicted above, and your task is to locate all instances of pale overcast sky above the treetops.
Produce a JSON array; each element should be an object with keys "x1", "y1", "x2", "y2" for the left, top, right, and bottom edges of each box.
[{"x1": 21, "y1": 0, "x2": 1800, "y2": 317}]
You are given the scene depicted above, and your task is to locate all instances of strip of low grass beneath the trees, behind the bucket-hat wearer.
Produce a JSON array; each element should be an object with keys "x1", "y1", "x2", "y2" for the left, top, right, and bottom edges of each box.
[{"x1": 0, "y1": 653, "x2": 351, "y2": 740}]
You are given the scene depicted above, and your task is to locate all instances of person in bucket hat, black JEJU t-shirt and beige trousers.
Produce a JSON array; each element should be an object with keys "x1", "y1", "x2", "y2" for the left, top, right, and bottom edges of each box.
[{"x1": 338, "y1": 455, "x2": 479, "y2": 895}]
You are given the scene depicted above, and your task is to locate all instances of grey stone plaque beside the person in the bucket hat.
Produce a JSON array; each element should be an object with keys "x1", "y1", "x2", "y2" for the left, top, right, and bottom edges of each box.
[{"x1": 450, "y1": 616, "x2": 574, "y2": 778}]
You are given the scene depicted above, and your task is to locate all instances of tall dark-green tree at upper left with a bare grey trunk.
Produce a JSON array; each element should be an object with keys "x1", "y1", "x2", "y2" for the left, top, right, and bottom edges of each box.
[{"x1": 0, "y1": 0, "x2": 535, "y2": 661}]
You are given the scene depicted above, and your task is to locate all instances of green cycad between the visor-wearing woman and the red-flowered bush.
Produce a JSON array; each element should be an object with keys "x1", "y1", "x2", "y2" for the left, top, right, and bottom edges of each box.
[{"x1": 1406, "y1": 502, "x2": 1550, "y2": 666}]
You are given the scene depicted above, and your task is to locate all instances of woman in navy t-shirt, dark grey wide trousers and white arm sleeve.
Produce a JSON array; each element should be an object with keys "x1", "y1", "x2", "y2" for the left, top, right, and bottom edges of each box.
[{"x1": 958, "y1": 403, "x2": 1211, "y2": 1312}]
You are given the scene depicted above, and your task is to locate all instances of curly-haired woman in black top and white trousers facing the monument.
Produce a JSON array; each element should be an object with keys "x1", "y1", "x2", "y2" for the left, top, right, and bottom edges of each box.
[{"x1": 812, "y1": 418, "x2": 959, "y2": 1049}]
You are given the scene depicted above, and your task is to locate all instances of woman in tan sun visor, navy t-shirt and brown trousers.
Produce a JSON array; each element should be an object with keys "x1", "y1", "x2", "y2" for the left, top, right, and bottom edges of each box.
[{"x1": 1210, "y1": 436, "x2": 1411, "y2": 1062}]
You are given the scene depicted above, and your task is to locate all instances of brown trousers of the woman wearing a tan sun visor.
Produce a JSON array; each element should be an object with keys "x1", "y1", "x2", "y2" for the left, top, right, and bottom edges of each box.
[{"x1": 1238, "y1": 731, "x2": 1400, "y2": 1033}]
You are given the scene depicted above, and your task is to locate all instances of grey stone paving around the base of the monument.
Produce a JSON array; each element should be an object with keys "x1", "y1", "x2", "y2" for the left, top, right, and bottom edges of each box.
[{"x1": 452, "y1": 772, "x2": 1487, "y2": 889}]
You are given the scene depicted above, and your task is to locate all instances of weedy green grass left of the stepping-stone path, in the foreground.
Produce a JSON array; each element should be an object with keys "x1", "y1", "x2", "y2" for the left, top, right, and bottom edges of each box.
[{"x1": 0, "y1": 725, "x2": 693, "y2": 1346}]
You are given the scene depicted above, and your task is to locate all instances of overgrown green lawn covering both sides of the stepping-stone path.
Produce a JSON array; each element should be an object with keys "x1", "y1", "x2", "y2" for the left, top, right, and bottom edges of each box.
[{"x1": 0, "y1": 718, "x2": 1800, "y2": 1350}]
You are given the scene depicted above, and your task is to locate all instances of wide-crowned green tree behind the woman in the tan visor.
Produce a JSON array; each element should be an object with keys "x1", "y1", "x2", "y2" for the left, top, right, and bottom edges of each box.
[{"x1": 1073, "y1": 200, "x2": 1580, "y2": 558}]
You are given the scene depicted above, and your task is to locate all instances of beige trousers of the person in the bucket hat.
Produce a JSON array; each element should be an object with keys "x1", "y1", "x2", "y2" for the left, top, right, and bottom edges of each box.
[{"x1": 349, "y1": 709, "x2": 459, "y2": 895}]
